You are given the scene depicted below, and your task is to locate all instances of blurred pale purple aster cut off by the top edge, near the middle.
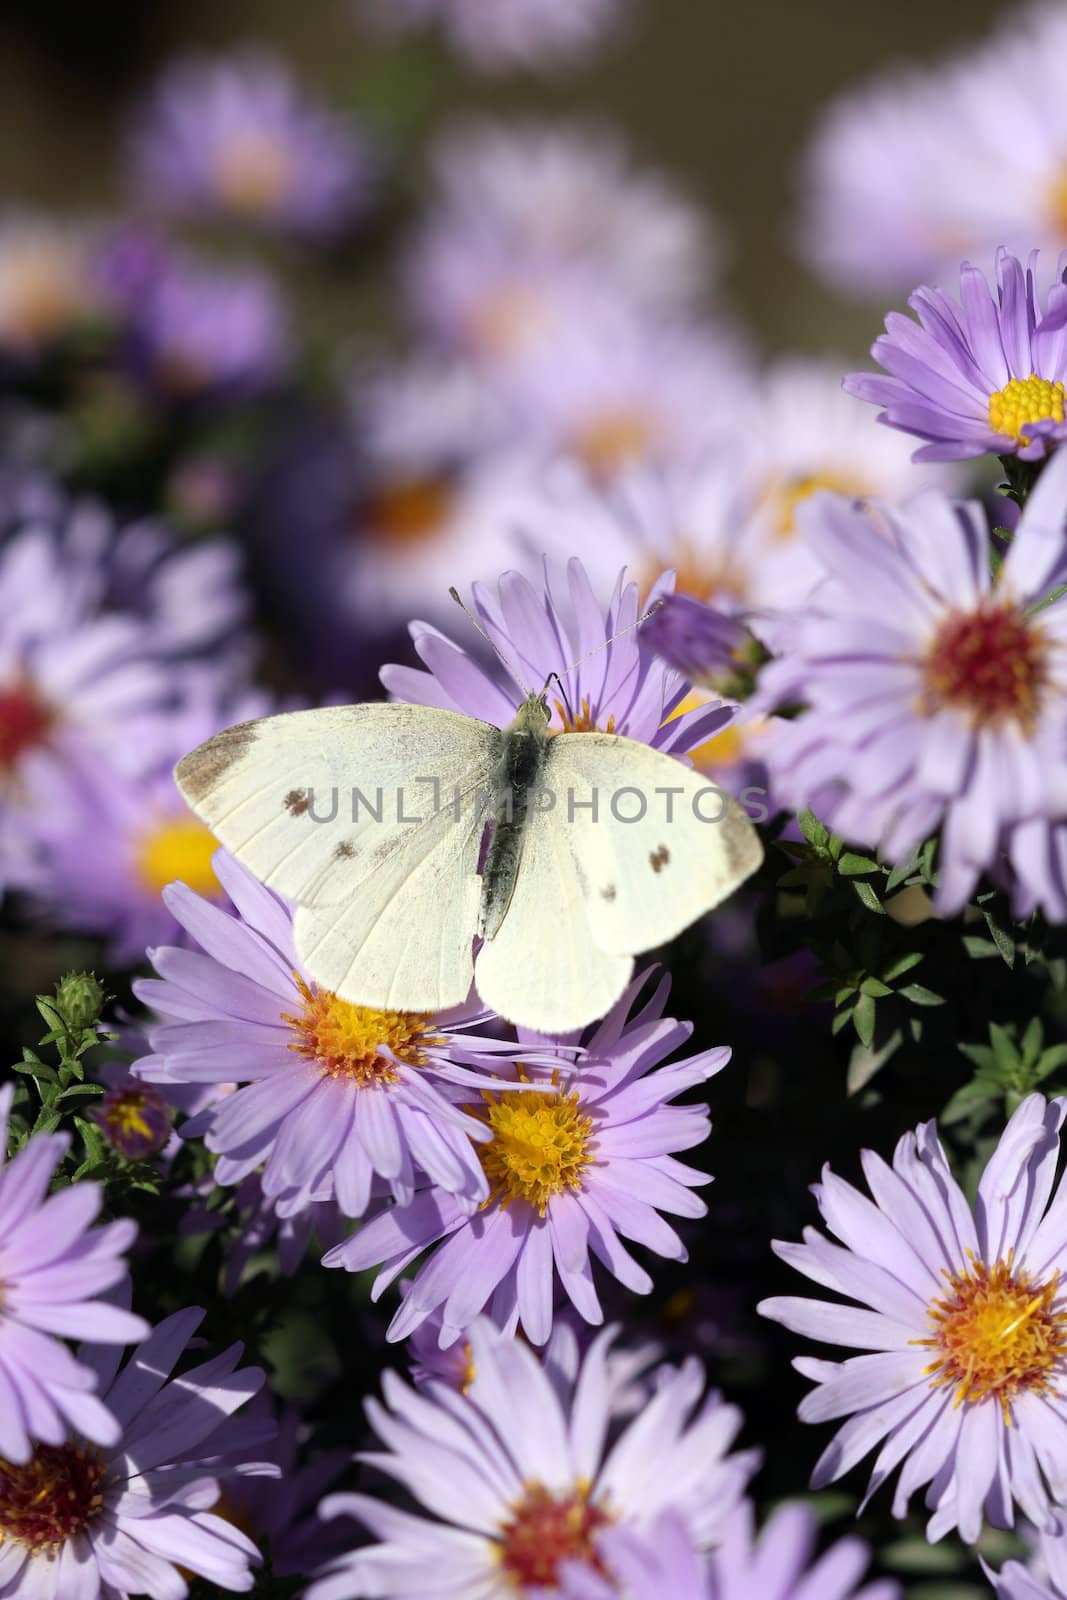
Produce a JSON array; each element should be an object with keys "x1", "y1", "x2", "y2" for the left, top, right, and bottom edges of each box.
[{"x1": 365, "y1": 0, "x2": 627, "y2": 72}]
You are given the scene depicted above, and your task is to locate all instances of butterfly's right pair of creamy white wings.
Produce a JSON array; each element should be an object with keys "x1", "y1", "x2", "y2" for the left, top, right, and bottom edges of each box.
[{"x1": 475, "y1": 733, "x2": 763, "y2": 1034}]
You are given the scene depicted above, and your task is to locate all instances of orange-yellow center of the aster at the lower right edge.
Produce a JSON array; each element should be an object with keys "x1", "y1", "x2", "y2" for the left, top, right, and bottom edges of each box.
[{"x1": 915, "y1": 1254, "x2": 1067, "y2": 1424}]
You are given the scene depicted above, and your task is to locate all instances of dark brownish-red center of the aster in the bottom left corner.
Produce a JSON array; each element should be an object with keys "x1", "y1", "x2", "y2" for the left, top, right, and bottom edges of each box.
[{"x1": 0, "y1": 1445, "x2": 106, "y2": 1550}]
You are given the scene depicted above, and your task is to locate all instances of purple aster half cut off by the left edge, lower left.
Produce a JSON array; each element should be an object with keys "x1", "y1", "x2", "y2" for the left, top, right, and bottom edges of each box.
[{"x1": 0, "y1": 1083, "x2": 149, "y2": 1465}]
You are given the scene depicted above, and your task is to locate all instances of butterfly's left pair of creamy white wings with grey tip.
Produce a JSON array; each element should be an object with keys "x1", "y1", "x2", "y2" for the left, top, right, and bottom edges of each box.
[{"x1": 176, "y1": 704, "x2": 501, "y2": 1011}]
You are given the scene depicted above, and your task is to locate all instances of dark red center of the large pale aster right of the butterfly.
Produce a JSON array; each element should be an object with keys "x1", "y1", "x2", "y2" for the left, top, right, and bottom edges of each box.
[{"x1": 923, "y1": 603, "x2": 1048, "y2": 726}]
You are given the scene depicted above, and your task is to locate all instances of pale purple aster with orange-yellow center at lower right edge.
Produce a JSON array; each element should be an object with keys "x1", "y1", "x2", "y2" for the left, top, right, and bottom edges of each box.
[{"x1": 760, "y1": 1094, "x2": 1067, "y2": 1542}]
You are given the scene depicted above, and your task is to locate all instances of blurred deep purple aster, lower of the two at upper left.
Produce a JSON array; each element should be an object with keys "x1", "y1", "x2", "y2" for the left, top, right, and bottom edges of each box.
[{"x1": 128, "y1": 256, "x2": 291, "y2": 403}]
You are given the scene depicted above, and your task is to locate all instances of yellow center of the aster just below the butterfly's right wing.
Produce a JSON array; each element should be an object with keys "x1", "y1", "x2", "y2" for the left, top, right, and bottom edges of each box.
[{"x1": 477, "y1": 1090, "x2": 593, "y2": 1216}]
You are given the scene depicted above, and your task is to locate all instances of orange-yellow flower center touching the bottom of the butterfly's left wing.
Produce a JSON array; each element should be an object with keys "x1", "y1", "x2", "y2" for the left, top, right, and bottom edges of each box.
[{"x1": 282, "y1": 974, "x2": 440, "y2": 1088}]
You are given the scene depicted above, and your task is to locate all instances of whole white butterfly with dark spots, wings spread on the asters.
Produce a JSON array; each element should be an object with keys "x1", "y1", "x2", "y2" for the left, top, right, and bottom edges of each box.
[{"x1": 174, "y1": 652, "x2": 763, "y2": 1034}]
